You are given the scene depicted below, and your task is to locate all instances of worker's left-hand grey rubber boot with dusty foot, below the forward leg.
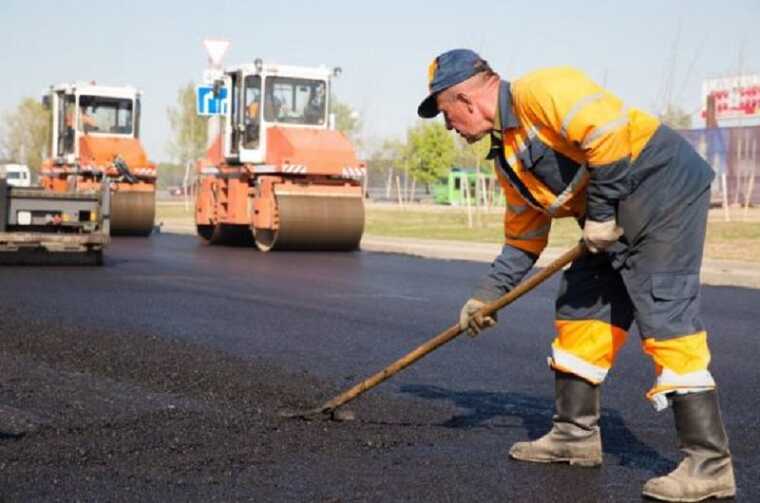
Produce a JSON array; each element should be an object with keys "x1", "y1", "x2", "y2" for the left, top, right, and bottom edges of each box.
[{"x1": 509, "y1": 371, "x2": 602, "y2": 466}]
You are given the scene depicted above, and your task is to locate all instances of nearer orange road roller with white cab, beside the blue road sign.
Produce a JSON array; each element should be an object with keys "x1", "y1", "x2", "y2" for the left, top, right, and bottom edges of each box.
[{"x1": 195, "y1": 59, "x2": 366, "y2": 252}]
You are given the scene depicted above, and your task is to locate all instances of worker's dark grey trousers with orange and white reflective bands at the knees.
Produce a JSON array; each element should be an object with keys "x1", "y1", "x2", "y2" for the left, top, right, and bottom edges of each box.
[{"x1": 550, "y1": 137, "x2": 715, "y2": 410}]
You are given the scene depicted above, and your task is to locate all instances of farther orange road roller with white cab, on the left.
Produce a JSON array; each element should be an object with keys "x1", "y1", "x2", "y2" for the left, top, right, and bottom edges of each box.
[{"x1": 39, "y1": 82, "x2": 156, "y2": 236}]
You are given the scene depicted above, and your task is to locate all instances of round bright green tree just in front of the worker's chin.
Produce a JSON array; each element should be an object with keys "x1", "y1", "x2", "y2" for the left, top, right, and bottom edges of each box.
[{"x1": 402, "y1": 121, "x2": 457, "y2": 185}]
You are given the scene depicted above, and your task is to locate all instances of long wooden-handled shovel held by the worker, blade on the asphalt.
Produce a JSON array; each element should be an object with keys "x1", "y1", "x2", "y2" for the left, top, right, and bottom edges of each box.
[{"x1": 280, "y1": 242, "x2": 586, "y2": 419}]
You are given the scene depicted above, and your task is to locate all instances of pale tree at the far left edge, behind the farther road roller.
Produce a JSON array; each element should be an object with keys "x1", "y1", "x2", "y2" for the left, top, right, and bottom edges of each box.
[{"x1": 1, "y1": 98, "x2": 51, "y2": 171}]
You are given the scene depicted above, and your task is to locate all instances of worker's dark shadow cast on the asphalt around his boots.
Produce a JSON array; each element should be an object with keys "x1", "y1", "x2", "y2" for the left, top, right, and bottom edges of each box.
[{"x1": 401, "y1": 385, "x2": 676, "y2": 474}]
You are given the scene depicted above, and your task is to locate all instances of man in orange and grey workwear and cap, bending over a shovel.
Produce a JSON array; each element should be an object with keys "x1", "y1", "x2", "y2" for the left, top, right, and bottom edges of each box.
[{"x1": 418, "y1": 49, "x2": 735, "y2": 501}]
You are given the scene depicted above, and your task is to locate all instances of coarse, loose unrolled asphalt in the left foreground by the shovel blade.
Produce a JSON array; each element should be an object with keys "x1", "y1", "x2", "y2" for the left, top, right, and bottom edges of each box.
[{"x1": 0, "y1": 308, "x2": 464, "y2": 502}]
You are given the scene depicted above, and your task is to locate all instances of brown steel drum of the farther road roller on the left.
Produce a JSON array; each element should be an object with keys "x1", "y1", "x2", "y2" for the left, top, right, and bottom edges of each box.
[{"x1": 111, "y1": 190, "x2": 156, "y2": 236}]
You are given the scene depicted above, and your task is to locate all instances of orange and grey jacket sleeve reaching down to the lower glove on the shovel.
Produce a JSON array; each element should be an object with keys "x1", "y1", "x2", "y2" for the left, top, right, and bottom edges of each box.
[{"x1": 473, "y1": 172, "x2": 551, "y2": 302}]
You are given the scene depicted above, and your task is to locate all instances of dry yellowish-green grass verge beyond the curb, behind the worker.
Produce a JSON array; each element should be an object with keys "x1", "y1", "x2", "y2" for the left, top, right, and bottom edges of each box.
[{"x1": 156, "y1": 202, "x2": 760, "y2": 262}]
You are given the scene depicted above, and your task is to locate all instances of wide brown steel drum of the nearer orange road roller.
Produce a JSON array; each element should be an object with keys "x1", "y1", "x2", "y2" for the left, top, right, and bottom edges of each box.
[{"x1": 254, "y1": 193, "x2": 364, "y2": 251}]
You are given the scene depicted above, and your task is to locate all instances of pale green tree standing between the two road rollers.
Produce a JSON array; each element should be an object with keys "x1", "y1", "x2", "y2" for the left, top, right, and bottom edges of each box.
[{"x1": 166, "y1": 82, "x2": 208, "y2": 166}]
